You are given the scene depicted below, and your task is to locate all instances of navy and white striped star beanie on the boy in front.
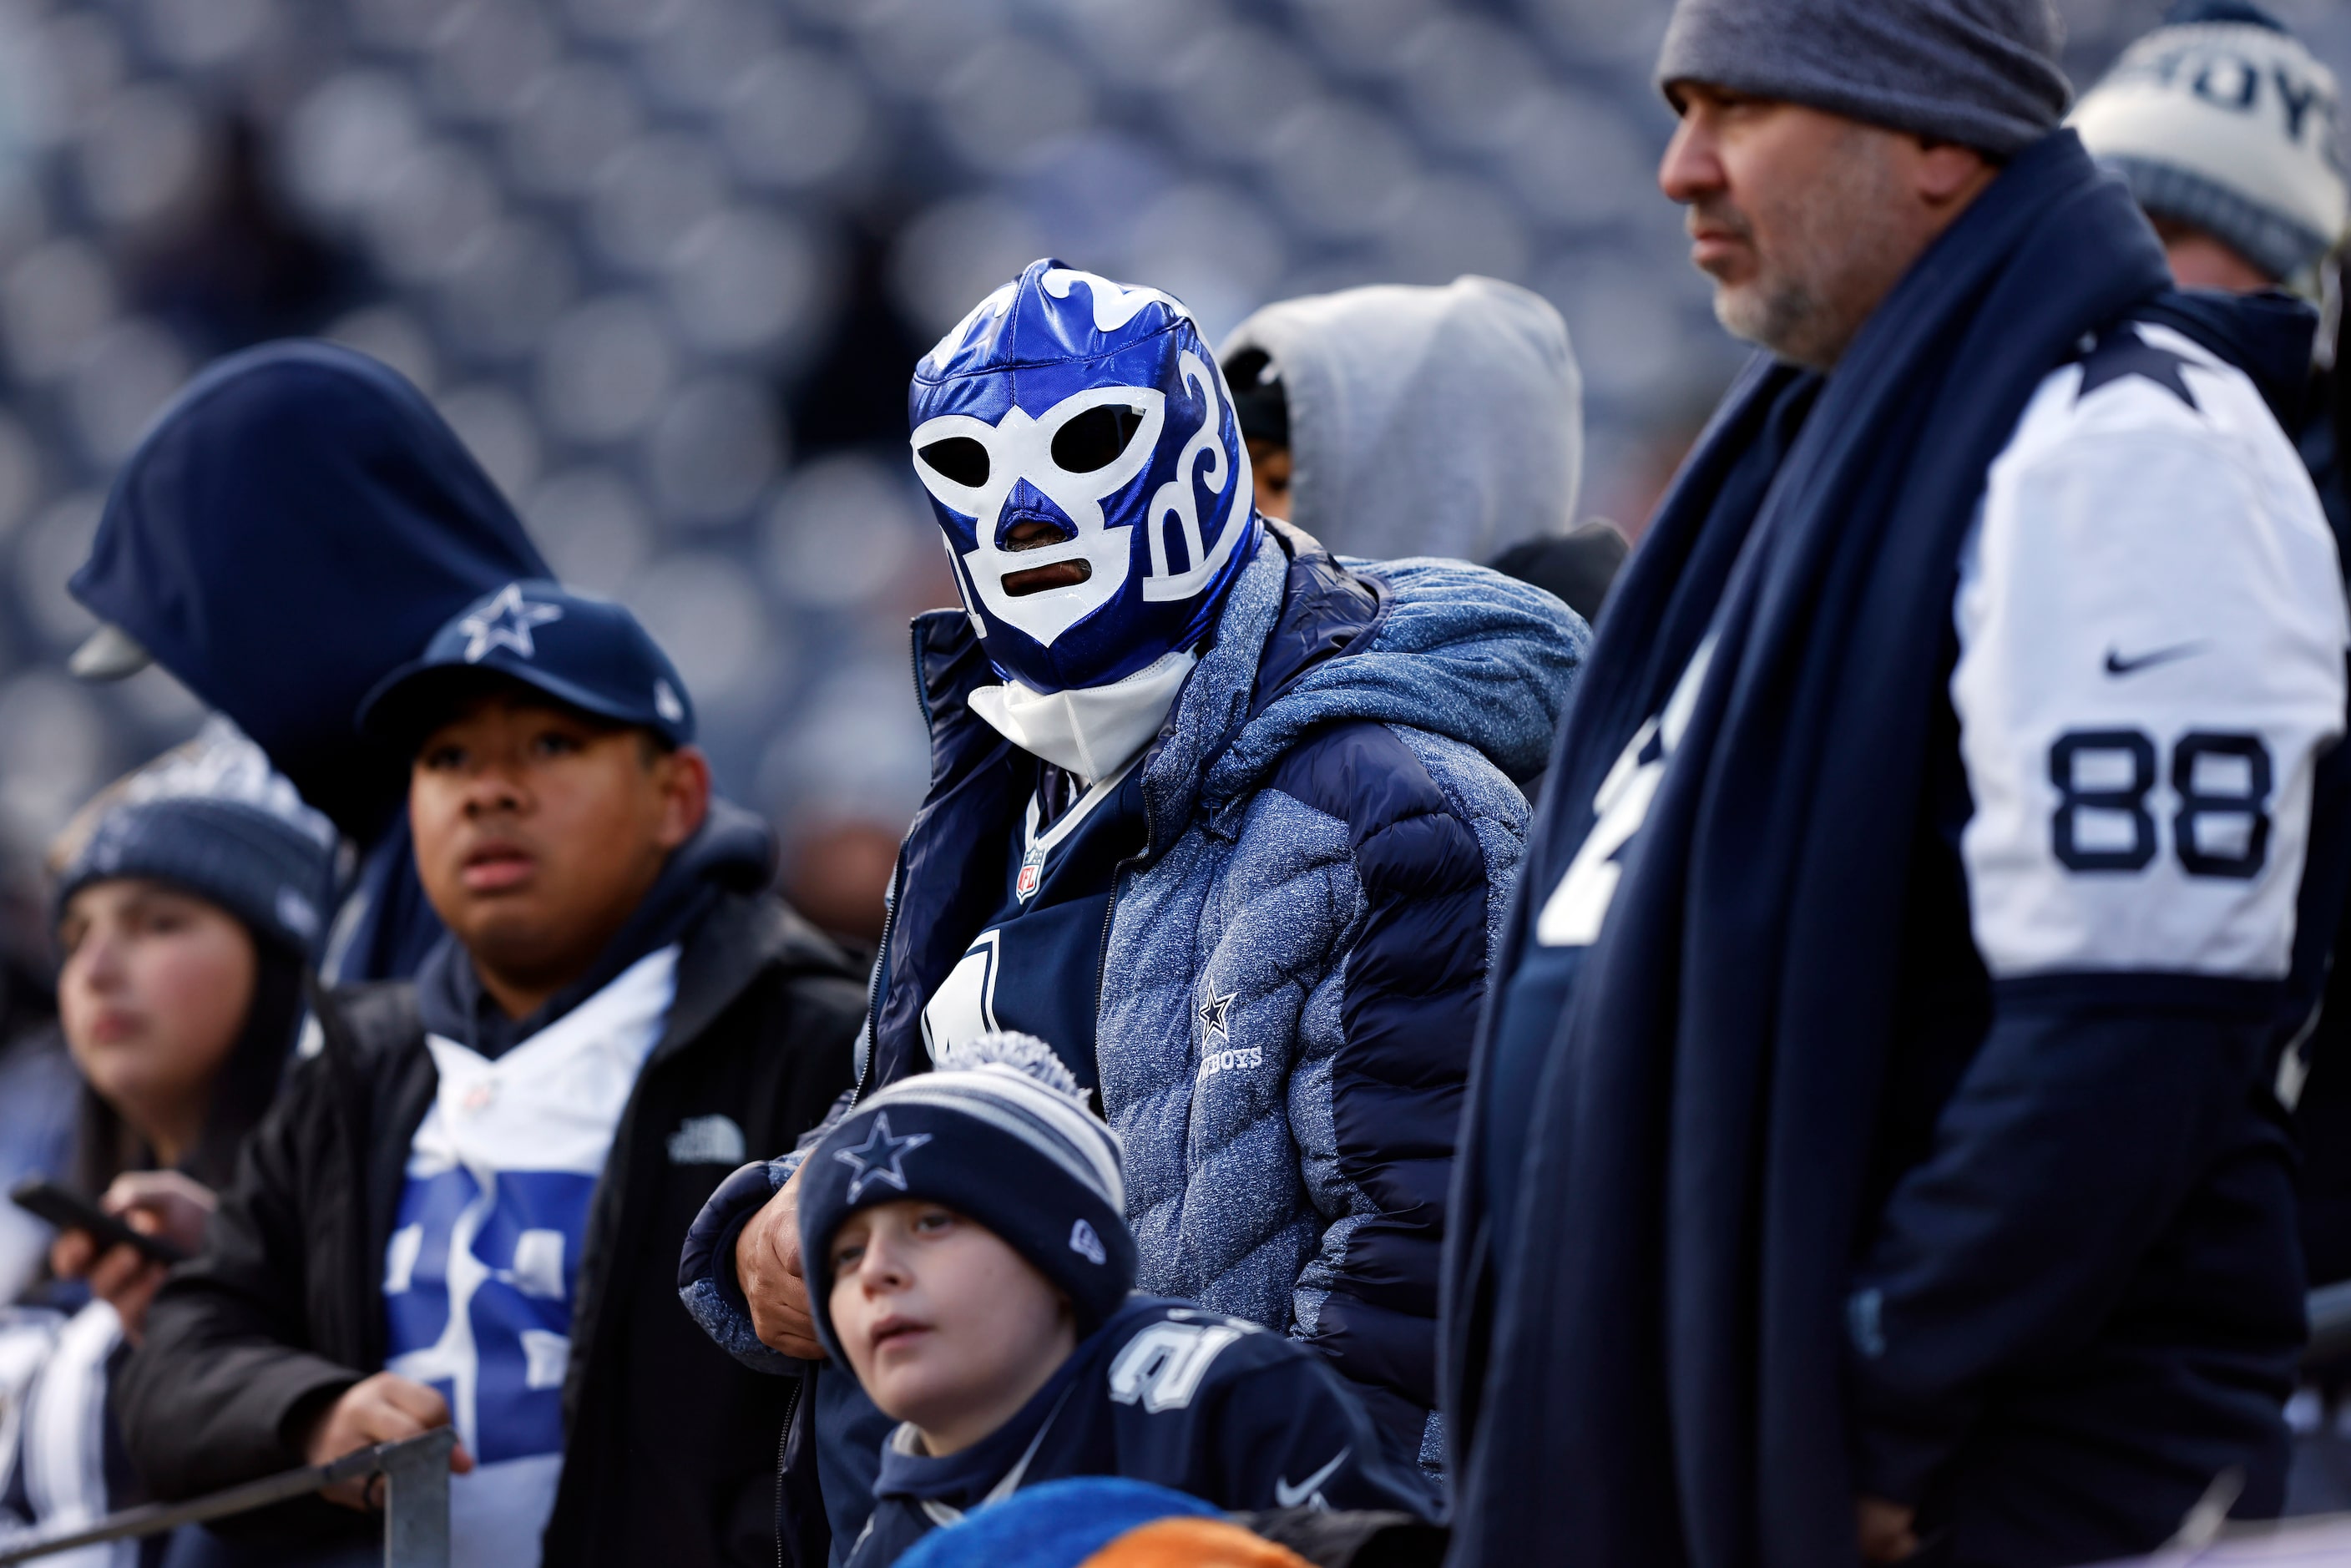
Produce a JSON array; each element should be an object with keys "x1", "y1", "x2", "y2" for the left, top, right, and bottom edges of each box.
[{"x1": 799, "y1": 1034, "x2": 1135, "y2": 1363}]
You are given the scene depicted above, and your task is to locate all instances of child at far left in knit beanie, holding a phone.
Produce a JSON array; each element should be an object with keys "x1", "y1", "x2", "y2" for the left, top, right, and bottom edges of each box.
[{"x1": 0, "y1": 731, "x2": 334, "y2": 1533}]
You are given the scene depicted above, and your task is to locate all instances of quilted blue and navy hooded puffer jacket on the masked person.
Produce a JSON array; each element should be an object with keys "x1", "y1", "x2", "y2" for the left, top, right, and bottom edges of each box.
[{"x1": 684, "y1": 524, "x2": 1590, "y2": 1459}]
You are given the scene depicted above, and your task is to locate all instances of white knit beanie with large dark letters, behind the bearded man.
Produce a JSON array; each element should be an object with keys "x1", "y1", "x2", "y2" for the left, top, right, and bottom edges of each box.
[{"x1": 2074, "y1": 0, "x2": 2351, "y2": 282}]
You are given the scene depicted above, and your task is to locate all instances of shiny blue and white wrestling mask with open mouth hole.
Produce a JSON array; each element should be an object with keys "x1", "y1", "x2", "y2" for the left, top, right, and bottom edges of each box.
[{"x1": 908, "y1": 261, "x2": 1258, "y2": 691}]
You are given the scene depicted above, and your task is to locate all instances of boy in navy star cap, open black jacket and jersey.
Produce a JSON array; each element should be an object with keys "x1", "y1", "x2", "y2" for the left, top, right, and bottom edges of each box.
[{"x1": 124, "y1": 580, "x2": 862, "y2": 1568}]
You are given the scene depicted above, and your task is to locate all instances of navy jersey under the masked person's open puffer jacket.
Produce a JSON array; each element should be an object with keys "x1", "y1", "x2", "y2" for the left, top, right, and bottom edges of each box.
[{"x1": 922, "y1": 757, "x2": 1145, "y2": 1089}]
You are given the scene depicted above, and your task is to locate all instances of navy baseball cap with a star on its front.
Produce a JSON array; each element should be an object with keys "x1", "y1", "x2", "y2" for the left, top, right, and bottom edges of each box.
[{"x1": 360, "y1": 579, "x2": 694, "y2": 750}]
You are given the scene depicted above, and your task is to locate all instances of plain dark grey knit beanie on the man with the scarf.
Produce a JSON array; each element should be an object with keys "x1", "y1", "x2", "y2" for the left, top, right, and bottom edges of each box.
[{"x1": 1657, "y1": 0, "x2": 2074, "y2": 158}]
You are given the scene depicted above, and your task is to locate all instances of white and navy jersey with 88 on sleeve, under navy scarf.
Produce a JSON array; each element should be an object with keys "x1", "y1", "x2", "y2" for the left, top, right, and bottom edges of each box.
[{"x1": 1484, "y1": 317, "x2": 2351, "y2": 1561}]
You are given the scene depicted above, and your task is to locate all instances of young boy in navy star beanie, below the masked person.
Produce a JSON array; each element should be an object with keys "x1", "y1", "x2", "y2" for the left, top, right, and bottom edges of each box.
[{"x1": 799, "y1": 1034, "x2": 1437, "y2": 1568}]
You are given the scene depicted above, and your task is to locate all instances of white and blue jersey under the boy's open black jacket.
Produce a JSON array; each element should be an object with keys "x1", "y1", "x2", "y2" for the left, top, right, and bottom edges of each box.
[{"x1": 383, "y1": 945, "x2": 677, "y2": 1568}]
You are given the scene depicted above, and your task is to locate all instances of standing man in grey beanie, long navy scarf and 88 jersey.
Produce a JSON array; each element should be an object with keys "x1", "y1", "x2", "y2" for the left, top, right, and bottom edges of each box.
[{"x1": 1441, "y1": 0, "x2": 2351, "y2": 1568}]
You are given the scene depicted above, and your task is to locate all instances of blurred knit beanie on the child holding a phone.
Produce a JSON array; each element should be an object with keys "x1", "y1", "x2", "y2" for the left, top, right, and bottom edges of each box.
[{"x1": 52, "y1": 720, "x2": 336, "y2": 959}]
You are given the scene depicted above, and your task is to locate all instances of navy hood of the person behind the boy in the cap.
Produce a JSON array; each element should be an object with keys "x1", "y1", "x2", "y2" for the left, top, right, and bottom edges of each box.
[{"x1": 70, "y1": 341, "x2": 553, "y2": 980}]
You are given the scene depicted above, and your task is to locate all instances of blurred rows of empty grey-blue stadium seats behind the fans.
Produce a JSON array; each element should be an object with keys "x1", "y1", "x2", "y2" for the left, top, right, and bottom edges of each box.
[{"x1": 0, "y1": 0, "x2": 2351, "y2": 933}]
